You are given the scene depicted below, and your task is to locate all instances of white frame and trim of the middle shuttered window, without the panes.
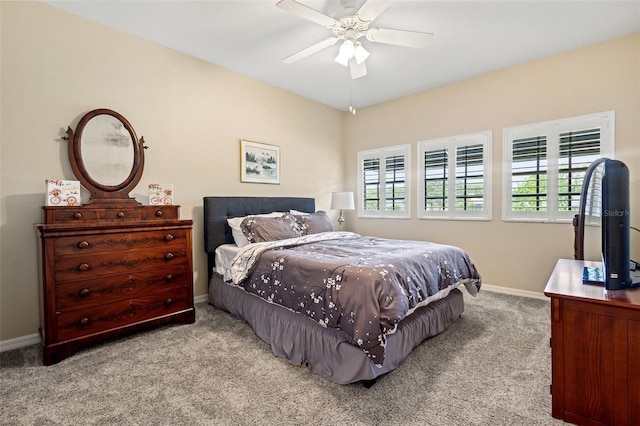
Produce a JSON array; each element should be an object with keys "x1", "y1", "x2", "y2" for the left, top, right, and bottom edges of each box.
[{"x1": 417, "y1": 130, "x2": 493, "y2": 220}]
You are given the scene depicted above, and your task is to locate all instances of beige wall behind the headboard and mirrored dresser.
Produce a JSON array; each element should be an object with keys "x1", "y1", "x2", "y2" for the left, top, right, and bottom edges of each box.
[{"x1": 0, "y1": 2, "x2": 343, "y2": 341}]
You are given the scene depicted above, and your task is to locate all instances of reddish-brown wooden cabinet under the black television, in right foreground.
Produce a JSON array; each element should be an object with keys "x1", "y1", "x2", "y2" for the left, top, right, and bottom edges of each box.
[{"x1": 545, "y1": 259, "x2": 640, "y2": 426}]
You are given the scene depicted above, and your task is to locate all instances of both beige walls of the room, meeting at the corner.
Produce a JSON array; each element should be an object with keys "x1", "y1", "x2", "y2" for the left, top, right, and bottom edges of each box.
[{"x1": 0, "y1": 2, "x2": 640, "y2": 342}]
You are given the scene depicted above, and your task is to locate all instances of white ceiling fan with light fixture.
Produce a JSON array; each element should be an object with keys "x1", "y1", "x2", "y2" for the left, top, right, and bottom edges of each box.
[{"x1": 276, "y1": 0, "x2": 433, "y2": 79}]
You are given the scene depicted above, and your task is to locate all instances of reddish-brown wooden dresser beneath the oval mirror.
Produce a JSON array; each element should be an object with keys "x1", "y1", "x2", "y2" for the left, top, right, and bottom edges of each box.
[{"x1": 37, "y1": 204, "x2": 195, "y2": 365}]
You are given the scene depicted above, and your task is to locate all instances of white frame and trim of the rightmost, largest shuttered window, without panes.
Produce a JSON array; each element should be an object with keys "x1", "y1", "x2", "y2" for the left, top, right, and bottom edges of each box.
[{"x1": 502, "y1": 111, "x2": 615, "y2": 223}]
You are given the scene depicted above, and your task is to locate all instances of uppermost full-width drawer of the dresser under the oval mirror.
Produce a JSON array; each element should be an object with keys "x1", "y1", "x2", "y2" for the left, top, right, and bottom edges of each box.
[{"x1": 53, "y1": 229, "x2": 187, "y2": 256}]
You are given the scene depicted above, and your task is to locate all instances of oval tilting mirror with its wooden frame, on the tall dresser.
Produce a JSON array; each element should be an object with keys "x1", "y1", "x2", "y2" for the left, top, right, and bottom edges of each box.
[{"x1": 67, "y1": 109, "x2": 144, "y2": 204}]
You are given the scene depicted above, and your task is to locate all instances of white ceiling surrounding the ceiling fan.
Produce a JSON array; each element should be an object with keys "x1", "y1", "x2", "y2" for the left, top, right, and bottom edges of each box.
[{"x1": 45, "y1": 0, "x2": 640, "y2": 110}]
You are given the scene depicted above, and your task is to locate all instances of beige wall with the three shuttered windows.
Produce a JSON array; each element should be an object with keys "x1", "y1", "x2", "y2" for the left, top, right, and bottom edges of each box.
[{"x1": 345, "y1": 34, "x2": 640, "y2": 292}]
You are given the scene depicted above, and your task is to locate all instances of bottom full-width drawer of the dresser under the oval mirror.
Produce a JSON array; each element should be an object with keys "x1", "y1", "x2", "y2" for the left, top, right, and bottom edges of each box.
[{"x1": 56, "y1": 286, "x2": 193, "y2": 340}]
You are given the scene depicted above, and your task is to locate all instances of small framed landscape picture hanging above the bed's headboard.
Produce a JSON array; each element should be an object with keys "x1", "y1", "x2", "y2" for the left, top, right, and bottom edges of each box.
[{"x1": 240, "y1": 139, "x2": 280, "y2": 184}]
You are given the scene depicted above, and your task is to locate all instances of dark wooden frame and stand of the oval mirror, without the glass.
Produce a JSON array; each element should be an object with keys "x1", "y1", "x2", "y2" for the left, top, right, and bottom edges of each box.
[{"x1": 67, "y1": 108, "x2": 146, "y2": 205}]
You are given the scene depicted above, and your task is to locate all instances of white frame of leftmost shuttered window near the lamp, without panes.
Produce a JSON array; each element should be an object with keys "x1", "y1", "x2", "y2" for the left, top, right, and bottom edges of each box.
[{"x1": 358, "y1": 144, "x2": 412, "y2": 219}]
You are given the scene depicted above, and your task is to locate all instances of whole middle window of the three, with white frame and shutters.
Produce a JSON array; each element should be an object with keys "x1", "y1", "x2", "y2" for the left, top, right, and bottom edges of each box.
[{"x1": 418, "y1": 131, "x2": 492, "y2": 220}]
